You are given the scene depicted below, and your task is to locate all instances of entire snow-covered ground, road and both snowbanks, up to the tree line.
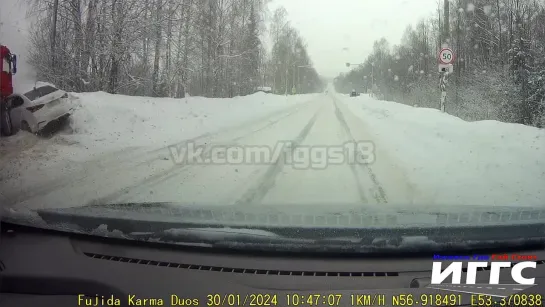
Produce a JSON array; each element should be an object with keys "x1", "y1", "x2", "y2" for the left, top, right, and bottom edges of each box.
[{"x1": 0, "y1": 90, "x2": 545, "y2": 214}]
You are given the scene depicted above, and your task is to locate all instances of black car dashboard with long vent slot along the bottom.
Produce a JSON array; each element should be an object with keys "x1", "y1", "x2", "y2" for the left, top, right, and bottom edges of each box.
[{"x1": 0, "y1": 223, "x2": 545, "y2": 307}]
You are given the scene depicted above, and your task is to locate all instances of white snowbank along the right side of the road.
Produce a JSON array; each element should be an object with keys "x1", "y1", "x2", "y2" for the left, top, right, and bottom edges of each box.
[{"x1": 337, "y1": 95, "x2": 545, "y2": 206}]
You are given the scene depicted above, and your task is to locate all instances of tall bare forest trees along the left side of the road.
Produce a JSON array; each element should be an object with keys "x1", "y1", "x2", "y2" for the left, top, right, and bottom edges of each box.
[{"x1": 28, "y1": 0, "x2": 319, "y2": 97}]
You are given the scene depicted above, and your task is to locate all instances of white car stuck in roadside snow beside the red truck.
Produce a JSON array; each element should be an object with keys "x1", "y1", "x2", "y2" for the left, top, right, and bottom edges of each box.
[{"x1": 8, "y1": 85, "x2": 73, "y2": 133}]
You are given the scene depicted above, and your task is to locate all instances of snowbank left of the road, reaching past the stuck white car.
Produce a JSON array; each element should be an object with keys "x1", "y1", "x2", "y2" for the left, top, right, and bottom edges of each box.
[{"x1": 0, "y1": 92, "x2": 316, "y2": 193}]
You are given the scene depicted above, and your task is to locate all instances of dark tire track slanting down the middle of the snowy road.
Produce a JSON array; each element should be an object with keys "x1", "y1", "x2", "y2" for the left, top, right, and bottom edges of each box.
[{"x1": 234, "y1": 107, "x2": 322, "y2": 205}]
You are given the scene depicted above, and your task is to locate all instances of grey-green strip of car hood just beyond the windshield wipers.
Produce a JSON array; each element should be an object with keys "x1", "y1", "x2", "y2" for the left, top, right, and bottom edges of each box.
[{"x1": 31, "y1": 202, "x2": 545, "y2": 228}]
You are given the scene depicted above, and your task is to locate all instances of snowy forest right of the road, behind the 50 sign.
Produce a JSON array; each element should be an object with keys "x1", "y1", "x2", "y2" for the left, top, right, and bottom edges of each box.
[{"x1": 335, "y1": 0, "x2": 545, "y2": 127}]
